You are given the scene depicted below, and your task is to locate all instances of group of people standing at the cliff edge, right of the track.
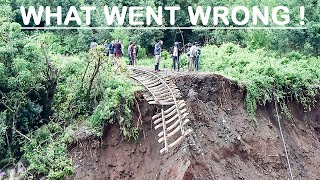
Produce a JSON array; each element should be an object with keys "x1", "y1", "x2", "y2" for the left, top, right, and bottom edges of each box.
[{"x1": 154, "y1": 40, "x2": 201, "y2": 72}]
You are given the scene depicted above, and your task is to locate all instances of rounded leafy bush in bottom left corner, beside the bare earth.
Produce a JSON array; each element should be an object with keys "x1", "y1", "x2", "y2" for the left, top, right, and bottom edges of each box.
[{"x1": 22, "y1": 123, "x2": 73, "y2": 179}]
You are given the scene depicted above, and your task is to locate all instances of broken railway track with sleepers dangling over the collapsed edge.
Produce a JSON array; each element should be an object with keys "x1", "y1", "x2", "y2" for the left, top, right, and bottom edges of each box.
[{"x1": 129, "y1": 67, "x2": 192, "y2": 154}]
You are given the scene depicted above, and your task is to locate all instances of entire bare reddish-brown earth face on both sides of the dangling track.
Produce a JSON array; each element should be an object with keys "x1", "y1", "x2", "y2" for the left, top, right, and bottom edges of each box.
[{"x1": 68, "y1": 74, "x2": 320, "y2": 180}]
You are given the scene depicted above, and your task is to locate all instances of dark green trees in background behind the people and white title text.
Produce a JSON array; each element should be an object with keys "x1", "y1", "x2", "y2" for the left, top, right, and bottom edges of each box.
[{"x1": 3, "y1": 0, "x2": 320, "y2": 55}]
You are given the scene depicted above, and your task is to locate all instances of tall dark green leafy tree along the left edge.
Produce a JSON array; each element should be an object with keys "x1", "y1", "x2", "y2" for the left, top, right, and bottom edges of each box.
[{"x1": 0, "y1": 22, "x2": 49, "y2": 165}]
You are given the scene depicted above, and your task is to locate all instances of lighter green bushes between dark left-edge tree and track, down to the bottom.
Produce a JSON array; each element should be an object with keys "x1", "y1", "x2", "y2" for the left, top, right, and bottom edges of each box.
[{"x1": 17, "y1": 49, "x2": 139, "y2": 179}]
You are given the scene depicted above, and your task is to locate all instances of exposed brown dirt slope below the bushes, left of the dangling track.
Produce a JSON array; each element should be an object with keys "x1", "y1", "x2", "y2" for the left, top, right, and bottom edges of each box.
[{"x1": 68, "y1": 94, "x2": 190, "y2": 180}]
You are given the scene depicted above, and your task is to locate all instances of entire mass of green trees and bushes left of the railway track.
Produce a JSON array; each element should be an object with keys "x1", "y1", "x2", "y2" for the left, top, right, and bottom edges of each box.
[{"x1": 0, "y1": 22, "x2": 139, "y2": 179}]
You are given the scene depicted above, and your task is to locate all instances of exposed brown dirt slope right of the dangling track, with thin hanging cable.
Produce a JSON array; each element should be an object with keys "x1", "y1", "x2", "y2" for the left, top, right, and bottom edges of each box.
[{"x1": 172, "y1": 75, "x2": 320, "y2": 179}]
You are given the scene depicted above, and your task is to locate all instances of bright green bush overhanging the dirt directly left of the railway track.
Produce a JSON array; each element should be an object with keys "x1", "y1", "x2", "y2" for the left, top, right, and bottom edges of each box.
[{"x1": 89, "y1": 76, "x2": 136, "y2": 139}]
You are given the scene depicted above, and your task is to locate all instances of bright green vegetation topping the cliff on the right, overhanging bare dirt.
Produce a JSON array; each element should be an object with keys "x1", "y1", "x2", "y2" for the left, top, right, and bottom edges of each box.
[{"x1": 201, "y1": 44, "x2": 320, "y2": 114}]
